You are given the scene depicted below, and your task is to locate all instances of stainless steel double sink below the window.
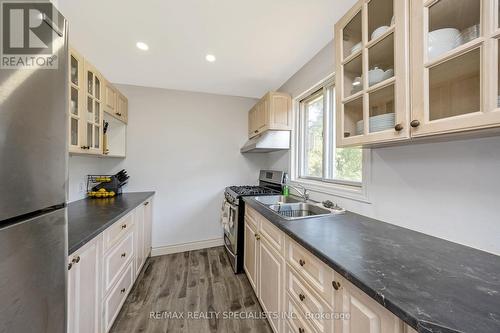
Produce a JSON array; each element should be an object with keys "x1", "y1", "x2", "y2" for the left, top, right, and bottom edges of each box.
[{"x1": 255, "y1": 195, "x2": 333, "y2": 221}]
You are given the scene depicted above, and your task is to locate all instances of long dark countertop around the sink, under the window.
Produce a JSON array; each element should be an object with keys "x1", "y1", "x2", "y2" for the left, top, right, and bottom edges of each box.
[{"x1": 245, "y1": 197, "x2": 500, "y2": 333}]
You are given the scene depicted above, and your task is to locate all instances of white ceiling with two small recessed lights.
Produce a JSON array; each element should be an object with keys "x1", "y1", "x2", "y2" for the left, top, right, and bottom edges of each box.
[{"x1": 57, "y1": 0, "x2": 355, "y2": 97}]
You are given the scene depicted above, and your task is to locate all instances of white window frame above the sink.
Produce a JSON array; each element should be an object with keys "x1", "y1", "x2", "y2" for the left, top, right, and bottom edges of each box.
[{"x1": 289, "y1": 74, "x2": 371, "y2": 202}]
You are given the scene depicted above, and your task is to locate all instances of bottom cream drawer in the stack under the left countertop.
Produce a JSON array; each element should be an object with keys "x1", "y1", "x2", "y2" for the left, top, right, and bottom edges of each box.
[{"x1": 104, "y1": 261, "x2": 134, "y2": 332}]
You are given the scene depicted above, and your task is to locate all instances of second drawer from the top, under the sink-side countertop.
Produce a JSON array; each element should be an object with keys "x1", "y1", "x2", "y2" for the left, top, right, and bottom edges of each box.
[{"x1": 286, "y1": 265, "x2": 334, "y2": 333}]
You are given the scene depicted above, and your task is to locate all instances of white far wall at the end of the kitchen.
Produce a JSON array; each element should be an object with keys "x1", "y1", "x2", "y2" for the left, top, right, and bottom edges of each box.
[{"x1": 70, "y1": 85, "x2": 268, "y2": 247}]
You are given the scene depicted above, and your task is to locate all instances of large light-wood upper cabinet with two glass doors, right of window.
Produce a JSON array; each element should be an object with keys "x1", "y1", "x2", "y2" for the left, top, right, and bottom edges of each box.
[{"x1": 335, "y1": 0, "x2": 500, "y2": 147}]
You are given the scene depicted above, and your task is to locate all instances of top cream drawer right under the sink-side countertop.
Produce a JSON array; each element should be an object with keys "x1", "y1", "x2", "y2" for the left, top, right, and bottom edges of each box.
[{"x1": 286, "y1": 237, "x2": 334, "y2": 306}]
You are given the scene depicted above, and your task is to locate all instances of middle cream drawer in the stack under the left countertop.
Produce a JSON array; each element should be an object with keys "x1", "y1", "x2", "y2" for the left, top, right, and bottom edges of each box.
[{"x1": 104, "y1": 232, "x2": 135, "y2": 293}]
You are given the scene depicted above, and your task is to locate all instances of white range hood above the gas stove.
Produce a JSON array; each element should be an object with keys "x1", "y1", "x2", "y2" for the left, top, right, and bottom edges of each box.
[{"x1": 240, "y1": 131, "x2": 290, "y2": 153}]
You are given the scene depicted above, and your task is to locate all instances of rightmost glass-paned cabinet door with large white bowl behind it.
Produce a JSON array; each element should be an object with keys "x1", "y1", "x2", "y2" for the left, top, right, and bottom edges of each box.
[{"x1": 410, "y1": 0, "x2": 500, "y2": 137}]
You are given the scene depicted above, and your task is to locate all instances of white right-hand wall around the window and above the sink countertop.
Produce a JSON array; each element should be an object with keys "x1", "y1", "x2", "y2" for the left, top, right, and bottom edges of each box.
[{"x1": 269, "y1": 43, "x2": 500, "y2": 255}]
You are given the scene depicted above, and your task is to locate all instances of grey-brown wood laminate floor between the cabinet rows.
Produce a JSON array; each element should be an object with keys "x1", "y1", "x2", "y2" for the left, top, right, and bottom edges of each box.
[{"x1": 110, "y1": 247, "x2": 272, "y2": 333}]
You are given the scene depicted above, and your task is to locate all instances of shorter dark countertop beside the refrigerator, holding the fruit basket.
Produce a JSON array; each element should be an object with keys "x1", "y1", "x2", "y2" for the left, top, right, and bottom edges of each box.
[{"x1": 68, "y1": 192, "x2": 155, "y2": 254}]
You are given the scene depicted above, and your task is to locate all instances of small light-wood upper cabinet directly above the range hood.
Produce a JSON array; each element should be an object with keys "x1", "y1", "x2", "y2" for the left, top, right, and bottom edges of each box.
[{"x1": 248, "y1": 92, "x2": 292, "y2": 138}]
